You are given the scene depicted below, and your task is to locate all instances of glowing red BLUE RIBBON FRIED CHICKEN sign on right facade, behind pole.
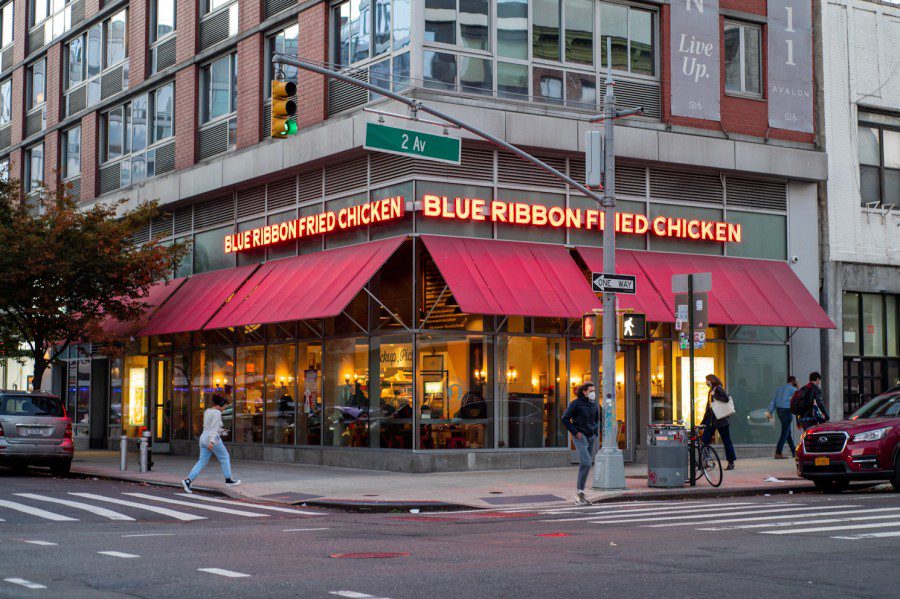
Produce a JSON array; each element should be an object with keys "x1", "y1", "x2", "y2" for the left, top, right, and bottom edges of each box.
[{"x1": 422, "y1": 194, "x2": 742, "y2": 243}]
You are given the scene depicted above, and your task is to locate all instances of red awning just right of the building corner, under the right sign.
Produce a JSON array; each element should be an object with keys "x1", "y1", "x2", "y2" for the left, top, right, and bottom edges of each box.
[{"x1": 422, "y1": 235, "x2": 600, "y2": 318}]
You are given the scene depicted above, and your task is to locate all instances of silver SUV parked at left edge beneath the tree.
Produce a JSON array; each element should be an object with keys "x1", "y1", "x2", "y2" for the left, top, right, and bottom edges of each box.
[{"x1": 0, "y1": 390, "x2": 75, "y2": 475}]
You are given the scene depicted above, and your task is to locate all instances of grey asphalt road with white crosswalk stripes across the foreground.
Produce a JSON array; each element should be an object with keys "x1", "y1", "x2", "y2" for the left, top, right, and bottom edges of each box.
[{"x1": 0, "y1": 471, "x2": 900, "y2": 599}]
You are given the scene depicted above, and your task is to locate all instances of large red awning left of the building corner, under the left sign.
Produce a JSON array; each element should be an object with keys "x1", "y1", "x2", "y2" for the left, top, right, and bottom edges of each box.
[{"x1": 203, "y1": 237, "x2": 406, "y2": 329}]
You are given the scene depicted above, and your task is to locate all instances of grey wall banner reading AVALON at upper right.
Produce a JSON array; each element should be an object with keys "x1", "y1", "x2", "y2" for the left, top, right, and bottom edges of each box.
[{"x1": 768, "y1": 0, "x2": 813, "y2": 133}]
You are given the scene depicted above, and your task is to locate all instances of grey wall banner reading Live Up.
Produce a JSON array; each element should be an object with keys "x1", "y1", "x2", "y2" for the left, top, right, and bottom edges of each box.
[{"x1": 670, "y1": 0, "x2": 721, "y2": 121}]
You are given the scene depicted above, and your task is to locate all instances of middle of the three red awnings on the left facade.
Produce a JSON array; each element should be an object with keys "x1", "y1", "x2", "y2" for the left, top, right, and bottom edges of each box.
[{"x1": 138, "y1": 264, "x2": 259, "y2": 337}]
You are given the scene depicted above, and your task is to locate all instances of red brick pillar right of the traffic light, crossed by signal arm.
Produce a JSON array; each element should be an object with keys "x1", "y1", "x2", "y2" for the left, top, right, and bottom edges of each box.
[{"x1": 297, "y1": 2, "x2": 328, "y2": 129}]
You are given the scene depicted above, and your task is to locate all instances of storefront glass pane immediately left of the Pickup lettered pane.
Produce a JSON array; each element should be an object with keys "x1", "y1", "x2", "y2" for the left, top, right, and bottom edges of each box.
[{"x1": 324, "y1": 337, "x2": 370, "y2": 447}]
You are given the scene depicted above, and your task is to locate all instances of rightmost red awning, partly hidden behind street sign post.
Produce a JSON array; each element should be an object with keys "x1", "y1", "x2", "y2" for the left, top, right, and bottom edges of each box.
[{"x1": 617, "y1": 252, "x2": 834, "y2": 328}]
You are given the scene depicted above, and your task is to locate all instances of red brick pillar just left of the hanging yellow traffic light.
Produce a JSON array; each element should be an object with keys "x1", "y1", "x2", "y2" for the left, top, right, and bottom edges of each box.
[{"x1": 237, "y1": 33, "x2": 265, "y2": 148}]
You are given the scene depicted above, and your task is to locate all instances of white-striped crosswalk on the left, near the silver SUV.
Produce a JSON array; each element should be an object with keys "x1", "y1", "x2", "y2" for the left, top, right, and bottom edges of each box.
[{"x1": 0, "y1": 487, "x2": 326, "y2": 526}]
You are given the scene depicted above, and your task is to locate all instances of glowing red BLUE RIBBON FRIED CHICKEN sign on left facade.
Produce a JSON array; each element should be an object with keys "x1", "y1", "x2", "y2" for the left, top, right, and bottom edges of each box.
[{"x1": 225, "y1": 196, "x2": 405, "y2": 254}]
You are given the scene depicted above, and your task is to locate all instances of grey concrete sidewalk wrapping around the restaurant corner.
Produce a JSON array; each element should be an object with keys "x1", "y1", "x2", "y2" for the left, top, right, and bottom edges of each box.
[{"x1": 72, "y1": 451, "x2": 814, "y2": 510}]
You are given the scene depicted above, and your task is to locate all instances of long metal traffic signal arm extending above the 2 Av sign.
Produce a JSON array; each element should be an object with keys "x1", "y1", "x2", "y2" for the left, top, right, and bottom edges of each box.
[{"x1": 272, "y1": 53, "x2": 612, "y2": 204}]
